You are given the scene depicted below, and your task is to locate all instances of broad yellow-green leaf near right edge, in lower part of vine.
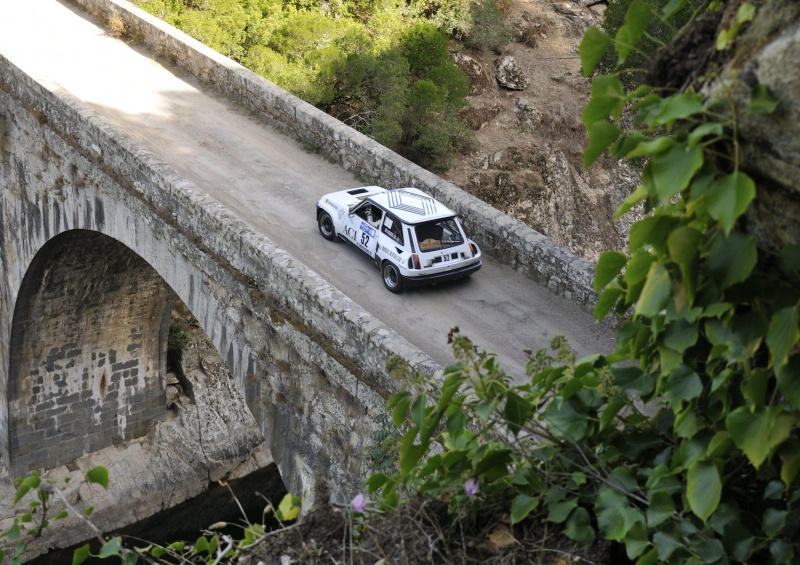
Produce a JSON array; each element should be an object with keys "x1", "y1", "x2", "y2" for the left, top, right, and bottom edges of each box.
[{"x1": 725, "y1": 406, "x2": 797, "y2": 468}]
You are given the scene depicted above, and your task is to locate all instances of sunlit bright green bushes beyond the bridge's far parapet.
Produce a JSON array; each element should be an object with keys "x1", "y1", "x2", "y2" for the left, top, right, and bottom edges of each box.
[{"x1": 130, "y1": 0, "x2": 511, "y2": 171}]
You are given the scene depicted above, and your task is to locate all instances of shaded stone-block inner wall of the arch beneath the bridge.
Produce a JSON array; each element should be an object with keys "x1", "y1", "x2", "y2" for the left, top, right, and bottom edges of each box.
[{"x1": 7, "y1": 230, "x2": 172, "y2": 475}]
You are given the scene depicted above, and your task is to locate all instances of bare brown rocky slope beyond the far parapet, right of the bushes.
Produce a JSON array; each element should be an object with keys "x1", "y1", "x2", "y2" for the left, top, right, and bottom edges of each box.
[{"x1": 444, "y1": 0, "x2": 638, "y2": 261}]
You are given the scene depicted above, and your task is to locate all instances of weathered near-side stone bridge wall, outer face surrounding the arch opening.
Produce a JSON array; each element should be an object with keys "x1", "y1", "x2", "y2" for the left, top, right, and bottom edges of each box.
[{"x1": 0, "y1": 50, "x2": 439, "y2": 493}]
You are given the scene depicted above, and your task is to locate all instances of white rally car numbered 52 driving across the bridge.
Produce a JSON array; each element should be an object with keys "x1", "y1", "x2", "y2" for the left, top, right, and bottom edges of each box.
[{"x1": 317, "y1": 186, "x2": 482, "y2": 292}]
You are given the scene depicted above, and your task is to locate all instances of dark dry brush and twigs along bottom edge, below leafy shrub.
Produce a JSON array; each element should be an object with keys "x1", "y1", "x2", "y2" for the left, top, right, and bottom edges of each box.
[{"x1": 241, "y1": 498, "x2": 624, "y2": 565}]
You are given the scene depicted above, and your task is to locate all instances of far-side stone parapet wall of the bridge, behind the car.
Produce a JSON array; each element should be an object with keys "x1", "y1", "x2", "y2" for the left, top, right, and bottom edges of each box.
[{"x1": 72, "y1": 0, "x2": 596, "y2": 311}]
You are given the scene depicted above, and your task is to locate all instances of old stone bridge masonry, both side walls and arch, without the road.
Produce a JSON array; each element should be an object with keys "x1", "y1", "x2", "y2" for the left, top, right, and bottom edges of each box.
[{"x1": 0, "y1": 0, "x2": 594, "y2": 536}]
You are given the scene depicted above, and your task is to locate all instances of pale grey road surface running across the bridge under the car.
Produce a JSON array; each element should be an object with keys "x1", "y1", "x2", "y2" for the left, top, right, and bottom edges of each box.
[{"x1": 0, "y1": 0, "x2": 613, "y2": 376}]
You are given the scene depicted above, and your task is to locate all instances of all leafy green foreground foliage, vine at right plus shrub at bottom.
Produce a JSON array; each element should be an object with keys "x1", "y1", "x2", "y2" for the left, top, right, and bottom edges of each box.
[{"x1": 367, "y1": 1, "x2": 800, "y2": 565}]
